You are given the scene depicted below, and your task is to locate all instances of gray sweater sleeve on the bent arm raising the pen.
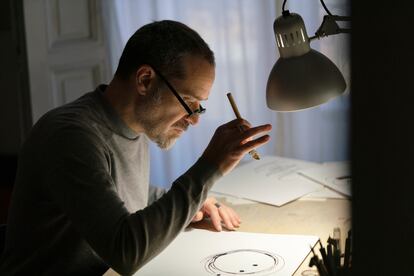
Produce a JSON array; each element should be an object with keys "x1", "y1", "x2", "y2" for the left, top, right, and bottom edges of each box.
[{"x1": 43, "y1": 127, "x2": 221, "y2": 275}]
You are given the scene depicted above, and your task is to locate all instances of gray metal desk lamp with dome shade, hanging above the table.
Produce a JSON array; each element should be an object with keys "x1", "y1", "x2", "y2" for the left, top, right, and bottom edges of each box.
[{"x1": 266, "y1": 0, "x2": 350, "y2": 111}]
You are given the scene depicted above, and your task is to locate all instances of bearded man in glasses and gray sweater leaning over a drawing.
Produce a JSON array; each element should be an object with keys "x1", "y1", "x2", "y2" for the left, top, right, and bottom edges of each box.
[{"x1": 0, "y1": 21, "x2": 271, "y2": 275}]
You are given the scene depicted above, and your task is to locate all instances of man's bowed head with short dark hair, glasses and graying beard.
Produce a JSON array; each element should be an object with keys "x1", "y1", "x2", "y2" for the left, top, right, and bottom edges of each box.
[{"x1": 115, "y1": 20, "x2": 215, "y2": 148}]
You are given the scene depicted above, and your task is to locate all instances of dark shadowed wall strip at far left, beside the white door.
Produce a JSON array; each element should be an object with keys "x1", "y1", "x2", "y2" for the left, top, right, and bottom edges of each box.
[{"x1": 0, "y1": 0, "x2": 31, "y2": 224}]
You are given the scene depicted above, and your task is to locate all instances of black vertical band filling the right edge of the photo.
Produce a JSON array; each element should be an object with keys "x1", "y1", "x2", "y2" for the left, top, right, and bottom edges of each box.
[{"x1": 351, "y1": 1, "x2": 414, "y2": 275}]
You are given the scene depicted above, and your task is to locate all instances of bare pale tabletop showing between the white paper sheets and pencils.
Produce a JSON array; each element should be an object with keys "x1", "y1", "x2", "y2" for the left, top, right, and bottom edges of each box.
[{"x1": 104, "y1": 193, "x2": 351, "y2": 276}]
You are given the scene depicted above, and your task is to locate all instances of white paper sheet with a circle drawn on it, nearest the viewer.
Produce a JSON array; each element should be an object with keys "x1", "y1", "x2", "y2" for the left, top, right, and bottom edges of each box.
[{"x1": 134, "y1": 229, "x2": 318, "y2": 276}]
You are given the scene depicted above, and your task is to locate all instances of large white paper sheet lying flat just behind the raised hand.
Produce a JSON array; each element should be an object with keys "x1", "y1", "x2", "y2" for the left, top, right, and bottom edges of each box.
[{"x1": 212, "y1": 156, "x2": 321, "y2": 206}]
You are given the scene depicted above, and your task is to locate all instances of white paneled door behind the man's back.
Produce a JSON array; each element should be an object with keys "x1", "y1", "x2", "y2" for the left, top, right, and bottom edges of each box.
[{"x1": 24, "y1": 0, "x2": 109, "y2": 122}]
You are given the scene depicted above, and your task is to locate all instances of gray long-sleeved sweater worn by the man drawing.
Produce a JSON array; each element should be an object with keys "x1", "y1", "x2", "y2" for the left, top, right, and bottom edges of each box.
[{"x1": 0, "y1": 85, "x2": 221, "y2": 275}]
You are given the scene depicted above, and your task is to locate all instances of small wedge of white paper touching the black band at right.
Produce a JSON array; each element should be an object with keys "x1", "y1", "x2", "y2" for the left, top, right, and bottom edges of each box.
[{"x1": 298, "y1": 161, "x2": 351, "y2": 196}]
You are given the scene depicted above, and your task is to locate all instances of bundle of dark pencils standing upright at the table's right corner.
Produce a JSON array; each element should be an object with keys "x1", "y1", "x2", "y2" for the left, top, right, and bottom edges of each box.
[{"x1": 309, "y1": 230, "x2": 352, "y2": 276}]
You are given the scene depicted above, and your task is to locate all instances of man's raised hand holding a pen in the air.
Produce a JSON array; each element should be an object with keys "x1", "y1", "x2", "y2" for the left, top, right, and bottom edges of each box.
[{"x1": 202, "y1": 119, "x2": 272, "y2": 175}]
